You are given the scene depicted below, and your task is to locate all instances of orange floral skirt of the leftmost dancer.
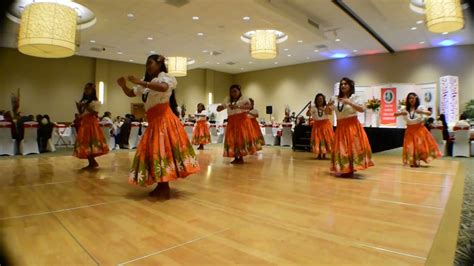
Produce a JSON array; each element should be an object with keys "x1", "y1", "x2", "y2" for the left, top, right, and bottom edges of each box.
[{"x1": 74, "y1": 114, "x2": 109, "y2": 159}]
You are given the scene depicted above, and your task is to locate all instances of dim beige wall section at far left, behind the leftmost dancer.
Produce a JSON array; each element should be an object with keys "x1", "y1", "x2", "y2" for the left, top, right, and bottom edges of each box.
[{"x1": 0, "y1": 48, "x2": 95, "y2": 121}]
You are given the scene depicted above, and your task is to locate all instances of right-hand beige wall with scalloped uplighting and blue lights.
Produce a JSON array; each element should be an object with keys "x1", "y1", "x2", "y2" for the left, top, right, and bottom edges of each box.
[{"x1": 234, "y1": 45, "x2": 474, "y2": 121}]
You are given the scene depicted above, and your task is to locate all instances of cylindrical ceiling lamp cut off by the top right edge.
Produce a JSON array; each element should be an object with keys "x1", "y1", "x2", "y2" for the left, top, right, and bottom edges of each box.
[{"x1": 425, "y1": 0, "x2": 464, "y2": 33}]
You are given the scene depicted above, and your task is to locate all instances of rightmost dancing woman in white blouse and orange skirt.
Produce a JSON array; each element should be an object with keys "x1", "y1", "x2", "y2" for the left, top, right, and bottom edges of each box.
[{"x1": 395, "y1": 92, "x2": 442, "y2": 167}]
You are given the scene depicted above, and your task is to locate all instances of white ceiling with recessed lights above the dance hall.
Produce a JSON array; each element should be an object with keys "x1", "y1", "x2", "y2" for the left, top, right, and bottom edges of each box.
[{"x1": 0, "y1": 0, "x2": 474, "y2": 73}]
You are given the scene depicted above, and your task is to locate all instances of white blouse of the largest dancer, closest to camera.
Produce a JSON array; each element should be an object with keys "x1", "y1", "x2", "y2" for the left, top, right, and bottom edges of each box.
[{"x1": 133, "y1": 72, "x2": 178, "y2": 111}]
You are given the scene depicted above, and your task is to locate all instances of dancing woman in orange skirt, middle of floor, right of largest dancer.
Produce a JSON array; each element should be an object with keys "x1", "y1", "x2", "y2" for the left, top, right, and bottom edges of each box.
[{"x1": 217, "y1": 84, "x2": 262, "y2": 164}]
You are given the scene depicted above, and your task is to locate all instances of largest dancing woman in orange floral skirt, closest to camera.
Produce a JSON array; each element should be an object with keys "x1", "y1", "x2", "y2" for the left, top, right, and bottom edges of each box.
[{"x1": 117, "y1": 54, "x2": 199, "y2": 199}]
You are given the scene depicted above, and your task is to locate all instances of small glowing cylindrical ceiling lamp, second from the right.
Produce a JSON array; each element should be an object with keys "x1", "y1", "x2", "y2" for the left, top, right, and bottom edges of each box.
[{"x1": 250, "y1": 30, "x2": 277, "y2": 59}]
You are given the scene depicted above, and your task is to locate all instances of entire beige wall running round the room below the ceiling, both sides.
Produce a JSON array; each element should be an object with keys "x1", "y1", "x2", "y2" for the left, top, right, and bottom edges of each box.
[{"x1": 0, "y1": 45, "x2": 474, "y2": 121}]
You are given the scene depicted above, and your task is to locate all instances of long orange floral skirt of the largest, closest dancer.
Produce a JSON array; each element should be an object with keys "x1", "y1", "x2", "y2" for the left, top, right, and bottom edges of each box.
[{"x1": 128, "y1": 103, "x2": 199, "y2": 186}]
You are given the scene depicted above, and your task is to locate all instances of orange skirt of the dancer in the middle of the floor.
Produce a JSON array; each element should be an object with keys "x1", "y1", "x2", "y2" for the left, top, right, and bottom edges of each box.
[{"x1": 224, "y1": 113, "x2": 262, "y2": 157}]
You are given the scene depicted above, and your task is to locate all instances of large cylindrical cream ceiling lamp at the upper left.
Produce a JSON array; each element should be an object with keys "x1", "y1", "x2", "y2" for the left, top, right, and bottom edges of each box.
[{"x1": 18, "y1": 2, "x2": 77, "y2": 58}]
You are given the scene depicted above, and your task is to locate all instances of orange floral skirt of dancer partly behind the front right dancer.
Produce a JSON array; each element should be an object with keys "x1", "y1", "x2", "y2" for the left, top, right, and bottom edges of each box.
[{"x1": 311, "y1": 119, "x2": 334, "y2": 155}]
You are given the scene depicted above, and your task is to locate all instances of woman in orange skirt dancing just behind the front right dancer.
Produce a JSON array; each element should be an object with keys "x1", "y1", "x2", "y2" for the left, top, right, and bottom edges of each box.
[{"x1": 306, "y1": 93, "x2": 334, "y2": 159}]
